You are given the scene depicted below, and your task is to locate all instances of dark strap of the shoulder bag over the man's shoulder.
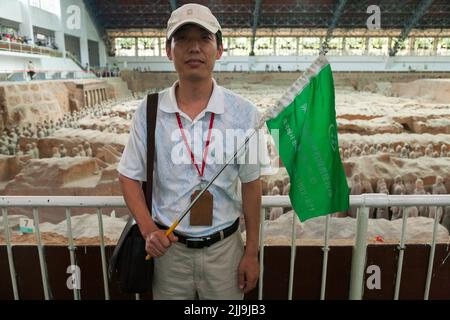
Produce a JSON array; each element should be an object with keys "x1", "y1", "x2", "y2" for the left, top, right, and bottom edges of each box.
[{"x1": 142, "y1": 93, "x2": 158, "y2": 215}]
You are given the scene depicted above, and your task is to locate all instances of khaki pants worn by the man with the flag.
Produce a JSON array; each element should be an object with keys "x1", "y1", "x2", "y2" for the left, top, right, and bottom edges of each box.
[{"x1": 153, "y1": 231, "x2": 244, "y2": 300}]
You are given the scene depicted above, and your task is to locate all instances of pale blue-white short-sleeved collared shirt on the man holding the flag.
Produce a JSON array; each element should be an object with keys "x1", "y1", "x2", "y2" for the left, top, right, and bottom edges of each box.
[{"x1": 118, "y1": 80, "x2": 267, "y2": 237}]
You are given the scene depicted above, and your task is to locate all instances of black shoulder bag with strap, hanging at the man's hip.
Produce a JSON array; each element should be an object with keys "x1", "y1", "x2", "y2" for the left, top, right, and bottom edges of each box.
[{"x1": 108, "y1": 93, "x2": 158, "y2": 293}]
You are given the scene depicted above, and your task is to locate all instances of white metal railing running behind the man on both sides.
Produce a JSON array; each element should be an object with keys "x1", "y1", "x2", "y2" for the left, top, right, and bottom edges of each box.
[{"x1": 0, "y1": 194, "x2": 450, "y2": 300}]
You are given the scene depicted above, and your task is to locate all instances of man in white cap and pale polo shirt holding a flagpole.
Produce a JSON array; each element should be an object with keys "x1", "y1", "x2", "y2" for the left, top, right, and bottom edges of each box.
[{"x1": 118, "y1": 4, "x2": 261, "y2": 299}]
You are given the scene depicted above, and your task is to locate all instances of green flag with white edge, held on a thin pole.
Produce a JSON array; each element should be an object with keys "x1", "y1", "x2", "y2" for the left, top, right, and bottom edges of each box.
[{"x1": 266, "y1": 55, "x2": 349, "y2": 221}]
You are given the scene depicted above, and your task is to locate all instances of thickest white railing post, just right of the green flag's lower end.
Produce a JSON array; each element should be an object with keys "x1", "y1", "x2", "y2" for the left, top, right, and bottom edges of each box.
[{"x1": 349, "y1": 207, "x2": 369, "y2": 300}]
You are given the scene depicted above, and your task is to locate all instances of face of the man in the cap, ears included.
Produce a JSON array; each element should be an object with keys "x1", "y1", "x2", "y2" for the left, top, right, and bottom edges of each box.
[{"x1": 166, "y1": 24, "x2": 223, "y2": 81}]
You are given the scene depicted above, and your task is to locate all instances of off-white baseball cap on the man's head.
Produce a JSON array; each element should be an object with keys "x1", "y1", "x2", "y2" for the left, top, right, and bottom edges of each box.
[{"x1": 167, "y1": 3, "x2": 221, "y2": 39}]
